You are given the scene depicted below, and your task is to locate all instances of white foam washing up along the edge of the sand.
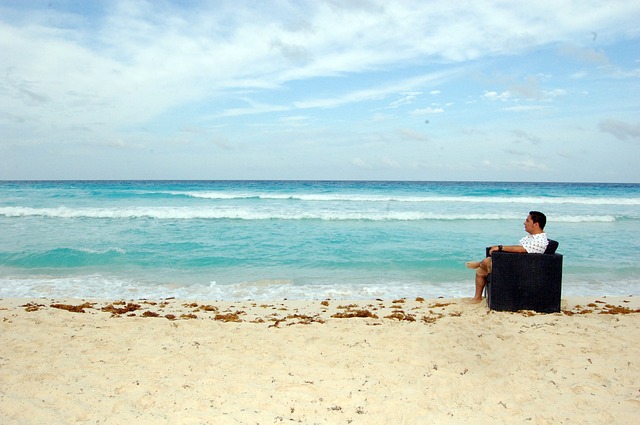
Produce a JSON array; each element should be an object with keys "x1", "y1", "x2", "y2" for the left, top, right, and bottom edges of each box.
[{"x1": 0, "y1": 274, "x2": 640, "y2": 301}]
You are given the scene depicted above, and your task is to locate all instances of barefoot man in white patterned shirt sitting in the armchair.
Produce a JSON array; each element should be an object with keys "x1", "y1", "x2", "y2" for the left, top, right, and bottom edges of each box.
[{"x1": 467, "y1": 211, "x2": 549, "y2": 304}]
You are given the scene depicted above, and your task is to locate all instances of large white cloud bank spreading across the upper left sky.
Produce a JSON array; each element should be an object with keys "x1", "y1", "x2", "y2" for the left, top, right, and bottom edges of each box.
[{"x1": 0, "y1": 0, "x2": 632, "y2": 125}]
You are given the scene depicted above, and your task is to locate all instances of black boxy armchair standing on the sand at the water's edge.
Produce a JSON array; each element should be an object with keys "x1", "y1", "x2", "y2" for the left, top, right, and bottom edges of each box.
[{"x1": 486, "y1": 240, "x2": 562, "y2": 313}]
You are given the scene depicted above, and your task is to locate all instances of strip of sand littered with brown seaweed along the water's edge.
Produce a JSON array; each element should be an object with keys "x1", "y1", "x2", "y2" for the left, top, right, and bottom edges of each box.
[{"x1": 0, "y1": 295, "x2": 640, "y2": 323}]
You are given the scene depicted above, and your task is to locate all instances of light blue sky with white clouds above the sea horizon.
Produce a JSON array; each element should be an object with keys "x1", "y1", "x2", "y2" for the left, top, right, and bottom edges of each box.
[{"x1": 0, "y1": 0, "x2": 640, "y2": 183}]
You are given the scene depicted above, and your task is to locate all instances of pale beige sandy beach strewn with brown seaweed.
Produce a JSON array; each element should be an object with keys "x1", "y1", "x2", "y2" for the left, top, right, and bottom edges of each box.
[{"x1": 0, "y1": 297, "x2": 640, "y2": 424}]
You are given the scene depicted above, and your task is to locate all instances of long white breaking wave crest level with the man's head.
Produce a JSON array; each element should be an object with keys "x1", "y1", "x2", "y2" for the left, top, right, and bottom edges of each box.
[{"x1": 0, "y1": 207, "x2": 616, "y2": 223}]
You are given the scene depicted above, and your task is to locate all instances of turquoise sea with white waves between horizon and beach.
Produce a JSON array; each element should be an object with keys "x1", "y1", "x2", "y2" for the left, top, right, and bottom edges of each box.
[{"x1": 0, "y1": 181, "x2": 640, "y2": 300}]
